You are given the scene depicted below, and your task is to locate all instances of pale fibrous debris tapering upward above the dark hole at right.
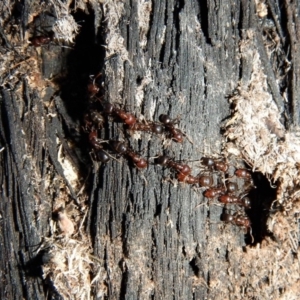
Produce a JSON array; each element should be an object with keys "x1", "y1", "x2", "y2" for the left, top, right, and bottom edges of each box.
[{"x1": 226, "y1": 31, "x2": 300, "y2": 204}]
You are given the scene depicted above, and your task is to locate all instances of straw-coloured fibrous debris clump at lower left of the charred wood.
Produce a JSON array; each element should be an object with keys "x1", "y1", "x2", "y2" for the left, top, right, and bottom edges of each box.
[{"x1": 41, "y1": 186, "x2": 97, "y2": 299}]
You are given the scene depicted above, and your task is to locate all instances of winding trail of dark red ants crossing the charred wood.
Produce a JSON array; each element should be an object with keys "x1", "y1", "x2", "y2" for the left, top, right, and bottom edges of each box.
[{"x1": 84, "y1": 74, "x2": 252, "y2": 236}]
